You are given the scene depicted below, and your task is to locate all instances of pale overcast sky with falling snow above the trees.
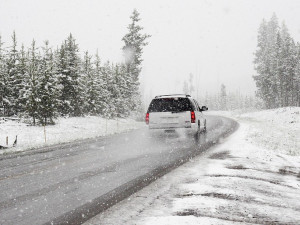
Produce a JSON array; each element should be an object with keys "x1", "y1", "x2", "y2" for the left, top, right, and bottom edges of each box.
[{"x1": 0, "y1": 0, "x2": 300, "y2": 102}]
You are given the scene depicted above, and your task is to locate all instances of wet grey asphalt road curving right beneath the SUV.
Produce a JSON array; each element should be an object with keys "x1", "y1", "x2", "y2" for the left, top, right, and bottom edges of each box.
[{"x1": 0, "y1": 116, "x2": 237, "y2": 225}]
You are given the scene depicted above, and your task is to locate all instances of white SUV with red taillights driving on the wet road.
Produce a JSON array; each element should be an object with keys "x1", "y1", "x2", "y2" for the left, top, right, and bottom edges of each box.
[{"x1": 146, "y1": 94, "x2": 208, "y2": 132}]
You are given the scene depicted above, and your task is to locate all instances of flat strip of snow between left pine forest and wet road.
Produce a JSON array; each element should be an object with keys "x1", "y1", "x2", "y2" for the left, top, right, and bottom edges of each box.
[{"x1": 0, "y1": 116, "x2": 145, "y2": 154}]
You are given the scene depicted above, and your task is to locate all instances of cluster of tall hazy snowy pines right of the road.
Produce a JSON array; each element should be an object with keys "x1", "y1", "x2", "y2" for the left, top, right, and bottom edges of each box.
[{"x1": 254, "y1": 14, "x2": 300, "y2": 109}]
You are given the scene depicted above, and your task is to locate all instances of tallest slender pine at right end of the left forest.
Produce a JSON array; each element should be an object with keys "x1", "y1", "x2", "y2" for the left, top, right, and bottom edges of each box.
[{"x1": 122, "y1": 9, "x2": 150, "y2": 114}]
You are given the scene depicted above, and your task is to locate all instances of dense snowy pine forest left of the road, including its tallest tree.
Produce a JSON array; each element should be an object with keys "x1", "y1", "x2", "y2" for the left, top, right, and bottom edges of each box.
[{"x1": 0, "y1": 10, "x2": 150, "y2": 125}]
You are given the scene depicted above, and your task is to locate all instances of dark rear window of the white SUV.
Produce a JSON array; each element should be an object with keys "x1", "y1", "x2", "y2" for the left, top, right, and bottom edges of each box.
[{"x1": 148, "y1": 98, "x2": 193, "y2": 113}]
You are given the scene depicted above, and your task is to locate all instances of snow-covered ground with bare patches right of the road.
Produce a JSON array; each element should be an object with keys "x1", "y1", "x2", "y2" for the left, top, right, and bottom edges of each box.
[{"x1": 86, "y1": 107, "x2": 300, "y2": 225}]
